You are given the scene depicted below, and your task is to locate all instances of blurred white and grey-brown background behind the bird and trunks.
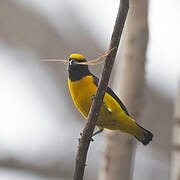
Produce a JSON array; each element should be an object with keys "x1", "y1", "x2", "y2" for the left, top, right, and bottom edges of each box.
[{"x1": 0, "y1": 0, "x2": 180, "y2": 180}]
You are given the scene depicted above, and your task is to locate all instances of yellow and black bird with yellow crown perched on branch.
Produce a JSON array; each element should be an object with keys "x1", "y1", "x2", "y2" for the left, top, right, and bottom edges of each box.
[{"x1": 68, "y1": 54, "x2": 153, "y2": 145}]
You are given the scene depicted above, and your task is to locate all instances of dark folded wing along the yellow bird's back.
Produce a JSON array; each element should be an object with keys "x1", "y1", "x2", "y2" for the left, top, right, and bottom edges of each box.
[{"x1": 92, "y1": 74, "x2": 130, "y2": 116}]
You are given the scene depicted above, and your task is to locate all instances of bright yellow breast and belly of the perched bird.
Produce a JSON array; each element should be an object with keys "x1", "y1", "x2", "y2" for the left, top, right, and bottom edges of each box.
[{"x1": 68, "y1": 76, "x2": 138, "y2": 133}]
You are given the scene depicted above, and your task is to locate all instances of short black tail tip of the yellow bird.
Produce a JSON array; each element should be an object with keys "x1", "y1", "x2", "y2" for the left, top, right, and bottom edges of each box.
[{"x1": 134, "y1": 123, "x2": 153, "y2": 145}]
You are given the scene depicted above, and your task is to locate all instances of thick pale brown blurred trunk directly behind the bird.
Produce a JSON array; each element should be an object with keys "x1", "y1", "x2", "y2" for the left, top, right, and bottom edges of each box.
[{"x1": 99, "y1": 0, "x2": 148, "y2": 180}]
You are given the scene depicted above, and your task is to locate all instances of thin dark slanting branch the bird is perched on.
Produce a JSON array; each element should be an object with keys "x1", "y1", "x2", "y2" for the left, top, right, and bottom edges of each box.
[{"x1": 73, "y1": 0, "x2": 129, "y2": 180}]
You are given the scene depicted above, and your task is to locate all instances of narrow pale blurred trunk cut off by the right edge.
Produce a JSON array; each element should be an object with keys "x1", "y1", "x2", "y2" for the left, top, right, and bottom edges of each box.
[{"x1": 171, "y1": 83, "x2": 180, "y2": 180}]
